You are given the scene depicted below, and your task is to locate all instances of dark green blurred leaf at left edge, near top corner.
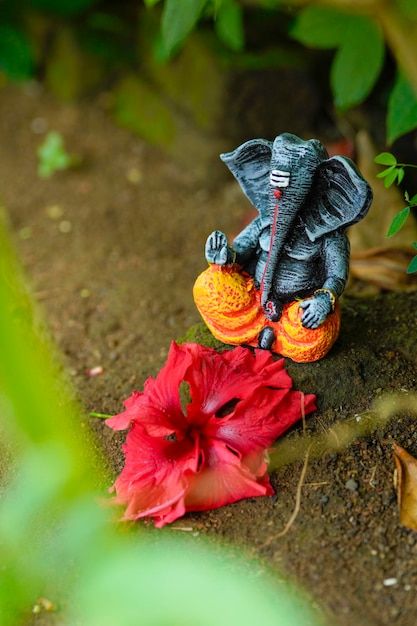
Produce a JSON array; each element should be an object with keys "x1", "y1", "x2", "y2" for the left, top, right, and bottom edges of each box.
[{"x1": 0, "y1": 24, "x2": 34, "y2": 80}]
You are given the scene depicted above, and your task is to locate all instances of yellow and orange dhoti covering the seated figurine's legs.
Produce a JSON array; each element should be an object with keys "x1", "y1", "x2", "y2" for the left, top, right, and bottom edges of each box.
[{"x1": 193, "y1": 265, "x2": 340, "y2": 363}]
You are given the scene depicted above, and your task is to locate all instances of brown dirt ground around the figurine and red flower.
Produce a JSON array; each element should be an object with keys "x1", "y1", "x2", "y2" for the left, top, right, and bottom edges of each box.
[{"x1": 0, "y1": 85, "x2": 417, "y2": 626}]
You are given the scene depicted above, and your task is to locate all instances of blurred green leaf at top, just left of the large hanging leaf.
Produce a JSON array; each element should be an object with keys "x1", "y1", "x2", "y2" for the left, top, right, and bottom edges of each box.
[{"x1": 290, "y1": 7, "x2": 344, "y2": 48}]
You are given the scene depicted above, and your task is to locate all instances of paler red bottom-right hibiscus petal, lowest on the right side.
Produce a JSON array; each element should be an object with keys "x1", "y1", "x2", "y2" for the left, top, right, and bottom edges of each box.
[{"x1": 185, "y1": 440, "x2": 273, "y2": 511}]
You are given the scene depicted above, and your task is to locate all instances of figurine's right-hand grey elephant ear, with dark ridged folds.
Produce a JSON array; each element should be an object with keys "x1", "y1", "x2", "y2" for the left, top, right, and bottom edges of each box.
[{"x1": 302, "y1": 156, "x2": 372, "y2": 241}]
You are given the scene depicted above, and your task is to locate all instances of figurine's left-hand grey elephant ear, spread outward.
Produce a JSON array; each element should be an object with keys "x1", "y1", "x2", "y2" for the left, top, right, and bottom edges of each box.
[{"x1": 220, "y1": 139, "x2": 272, "y2": 212}]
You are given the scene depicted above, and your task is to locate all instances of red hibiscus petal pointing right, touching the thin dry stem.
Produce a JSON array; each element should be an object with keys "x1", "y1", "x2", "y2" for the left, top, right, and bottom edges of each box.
[{"x1": 204, "y1": 387, "x2": 316, "y2": 455}]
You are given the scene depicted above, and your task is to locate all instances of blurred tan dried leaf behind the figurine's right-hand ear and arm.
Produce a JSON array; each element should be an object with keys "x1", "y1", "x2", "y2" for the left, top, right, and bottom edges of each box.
[{"x1": 349, "y1": 130, "x2": 417, "y2": 291}]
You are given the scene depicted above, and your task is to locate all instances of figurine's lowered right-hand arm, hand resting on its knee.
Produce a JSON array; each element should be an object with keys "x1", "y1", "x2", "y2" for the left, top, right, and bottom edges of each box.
[{"x1": 300, "y1": 232, "x2": 349, "y2": 328}]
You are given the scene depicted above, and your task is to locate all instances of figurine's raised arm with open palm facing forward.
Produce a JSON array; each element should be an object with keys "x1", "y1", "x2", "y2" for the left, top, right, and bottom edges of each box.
[{"x1": 206, "y1": 217, "x2": 261, "y2": 265}]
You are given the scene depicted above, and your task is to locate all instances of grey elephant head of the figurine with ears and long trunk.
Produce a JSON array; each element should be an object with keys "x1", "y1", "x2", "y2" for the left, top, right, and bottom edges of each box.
[{"x1": 220, "y1": 133, "x2": 372, "y2": 304}]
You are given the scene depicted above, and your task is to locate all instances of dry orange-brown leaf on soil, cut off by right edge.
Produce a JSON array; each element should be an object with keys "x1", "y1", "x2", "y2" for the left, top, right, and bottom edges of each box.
[{"x1": 394, "y1": 443, "x2": 417, "y2": 530}]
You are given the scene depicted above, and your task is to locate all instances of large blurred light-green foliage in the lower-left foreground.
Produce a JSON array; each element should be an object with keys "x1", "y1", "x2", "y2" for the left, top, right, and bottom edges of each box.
[{"x1": 0, "y1": 216, "x2": 322, "y2": 626}]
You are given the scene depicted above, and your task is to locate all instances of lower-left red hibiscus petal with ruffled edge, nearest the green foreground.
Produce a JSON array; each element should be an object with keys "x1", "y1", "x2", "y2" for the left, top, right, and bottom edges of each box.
[{"x1": 114, "y1": 423, "x2": 199, "y2": 526}]
